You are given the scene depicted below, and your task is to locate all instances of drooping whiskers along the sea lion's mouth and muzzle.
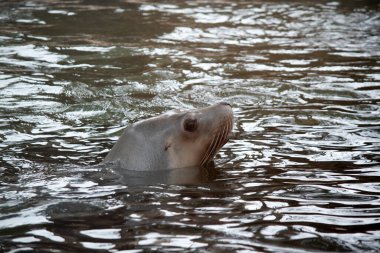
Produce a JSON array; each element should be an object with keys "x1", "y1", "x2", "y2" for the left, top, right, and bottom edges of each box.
[{"x1": 201, "y1": 115, "x2": 233, "y2": 167}]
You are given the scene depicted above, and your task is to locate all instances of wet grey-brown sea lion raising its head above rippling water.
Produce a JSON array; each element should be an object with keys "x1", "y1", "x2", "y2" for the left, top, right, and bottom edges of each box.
[{"x1": 103, "y1": 102, "x2": 233, "y2": 171}]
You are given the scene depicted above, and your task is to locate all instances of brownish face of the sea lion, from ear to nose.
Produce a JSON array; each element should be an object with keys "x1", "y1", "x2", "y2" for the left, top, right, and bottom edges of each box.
[{"x1": 165, "y1": 103, "x2": 233, "y2": 168}]
